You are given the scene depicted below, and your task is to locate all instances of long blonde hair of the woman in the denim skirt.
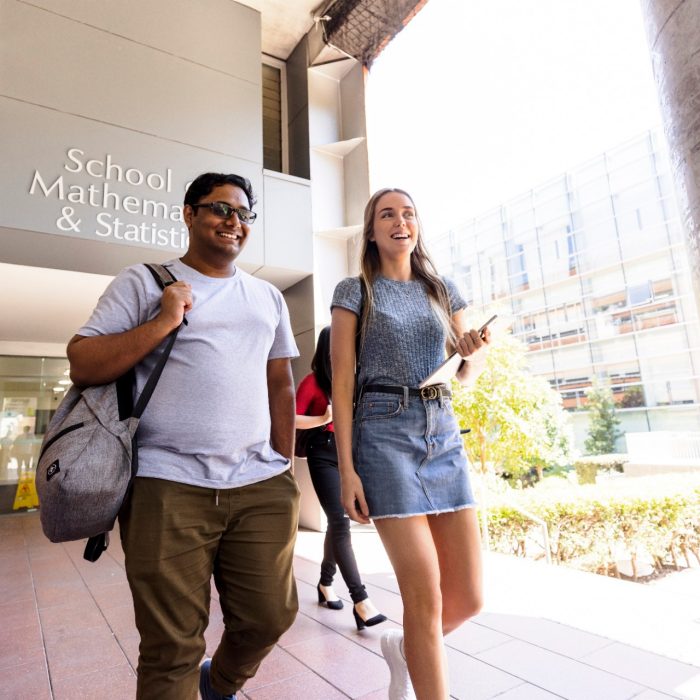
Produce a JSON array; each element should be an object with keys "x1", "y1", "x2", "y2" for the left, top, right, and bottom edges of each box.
[{"x1": 360, "y1": 187, "x2": 457, "y2": 351}]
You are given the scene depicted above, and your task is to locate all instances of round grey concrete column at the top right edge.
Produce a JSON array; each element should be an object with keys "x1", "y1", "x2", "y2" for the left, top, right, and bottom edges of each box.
[{"x1": 641, "y1": 0, "x2": 700, "y2": 303}]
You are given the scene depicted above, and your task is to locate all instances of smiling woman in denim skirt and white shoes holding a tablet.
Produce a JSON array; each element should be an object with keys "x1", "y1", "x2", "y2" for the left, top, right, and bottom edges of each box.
[{"x1": 331, "y1": 189, "x2": 490, "y2": 700}]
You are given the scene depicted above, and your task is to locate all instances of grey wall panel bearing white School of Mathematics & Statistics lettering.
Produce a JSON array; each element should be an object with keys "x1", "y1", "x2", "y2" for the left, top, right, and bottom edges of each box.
[{"x1": 0, "y1": 98, "x2": 265, "y2": 270}]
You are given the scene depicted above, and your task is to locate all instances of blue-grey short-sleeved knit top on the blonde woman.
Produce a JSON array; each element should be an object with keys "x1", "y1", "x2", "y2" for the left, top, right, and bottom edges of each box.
[{"x1": 331, "y1": 277, "x2": 467, "y2": 387}]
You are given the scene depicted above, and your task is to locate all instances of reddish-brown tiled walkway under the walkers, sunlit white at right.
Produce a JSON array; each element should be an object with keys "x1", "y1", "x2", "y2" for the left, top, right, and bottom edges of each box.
[{"x1": 0, "y1": 513, "x2": 700, "y2": 700}]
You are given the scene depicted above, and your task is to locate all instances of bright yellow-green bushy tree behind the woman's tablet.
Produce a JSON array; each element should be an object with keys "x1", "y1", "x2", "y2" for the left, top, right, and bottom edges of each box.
[{"x1": 454, "y1": 333, "x2": 573, "y2": 476}]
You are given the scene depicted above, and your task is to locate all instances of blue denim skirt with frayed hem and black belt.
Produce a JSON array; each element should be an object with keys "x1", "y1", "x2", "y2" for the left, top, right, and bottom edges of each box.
[{"x1": 352, "y1": 392, "x2": 475, "y2": 518}]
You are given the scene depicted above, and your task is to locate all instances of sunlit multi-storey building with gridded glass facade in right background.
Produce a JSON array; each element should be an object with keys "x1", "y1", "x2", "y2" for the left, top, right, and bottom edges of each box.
[{"x1": 432, "y1": 131, "x2": 700, "y2": 450}]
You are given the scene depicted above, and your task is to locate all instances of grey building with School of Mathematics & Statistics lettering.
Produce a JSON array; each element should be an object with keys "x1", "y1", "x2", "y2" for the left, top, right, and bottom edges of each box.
[{"x1": 0, "y1": 0, "x2": 422, "y2": 527}]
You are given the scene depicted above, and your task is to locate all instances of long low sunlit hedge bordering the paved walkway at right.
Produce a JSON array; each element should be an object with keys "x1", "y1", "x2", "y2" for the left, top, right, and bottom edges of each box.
[{"x1": 488, "y1": 475, "x2": 700, "y2": 576}]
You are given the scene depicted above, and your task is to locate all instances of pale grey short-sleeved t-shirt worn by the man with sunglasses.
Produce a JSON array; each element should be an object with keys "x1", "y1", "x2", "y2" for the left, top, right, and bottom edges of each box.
[{"x1": 78, "y1": 260, "x2": 299, "y2": 489}]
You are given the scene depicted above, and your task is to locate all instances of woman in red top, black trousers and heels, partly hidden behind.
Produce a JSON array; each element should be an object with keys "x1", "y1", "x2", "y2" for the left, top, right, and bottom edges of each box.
[{"x1": 296, "y1": 326, "x2": 386, "y2": 630}]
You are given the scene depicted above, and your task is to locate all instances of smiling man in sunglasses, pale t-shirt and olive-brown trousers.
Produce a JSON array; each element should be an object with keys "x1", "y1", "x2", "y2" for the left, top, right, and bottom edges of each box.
[{"x1": 68, "y1": 173, "x2": 299, "y2": 700}]
